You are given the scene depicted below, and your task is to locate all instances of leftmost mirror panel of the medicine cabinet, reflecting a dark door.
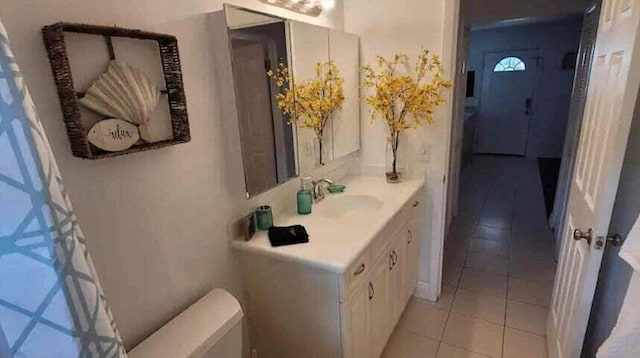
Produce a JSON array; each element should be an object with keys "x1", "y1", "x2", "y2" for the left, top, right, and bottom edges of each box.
[{"x1": 225, "y1": 6, "x2": 298, "y2": 197}]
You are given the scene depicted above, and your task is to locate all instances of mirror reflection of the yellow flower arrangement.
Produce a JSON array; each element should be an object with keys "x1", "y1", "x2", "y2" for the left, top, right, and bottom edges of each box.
[{"x1": 267, "y1": 61, "x2": 344, "y2": 165}]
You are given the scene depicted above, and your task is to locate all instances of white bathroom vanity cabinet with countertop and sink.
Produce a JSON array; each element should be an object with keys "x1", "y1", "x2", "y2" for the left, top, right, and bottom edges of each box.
[{"x1": 232, "y1": 177, "x2": 424, "y2": 358}]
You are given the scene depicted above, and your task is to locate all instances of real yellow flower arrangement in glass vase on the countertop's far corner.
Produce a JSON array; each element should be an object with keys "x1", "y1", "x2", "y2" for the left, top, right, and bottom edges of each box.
[{"x1": 362, "y1": 49, "x2": 453, "y2": 182}]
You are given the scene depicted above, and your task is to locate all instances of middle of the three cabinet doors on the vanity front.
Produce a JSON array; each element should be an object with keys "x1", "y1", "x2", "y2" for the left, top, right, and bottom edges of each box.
[{"x1": 369, "y1": 255, "x2": 391, "y2": 357}]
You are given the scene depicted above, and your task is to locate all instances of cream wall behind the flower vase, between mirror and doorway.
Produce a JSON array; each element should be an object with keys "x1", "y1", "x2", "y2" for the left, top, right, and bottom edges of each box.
[{"x1": 344, "y1": 0, "x2": 458, "y2": 298}]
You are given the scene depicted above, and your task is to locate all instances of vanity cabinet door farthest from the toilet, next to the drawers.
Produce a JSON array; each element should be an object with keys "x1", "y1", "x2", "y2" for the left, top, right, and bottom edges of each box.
[{"x1": 390, "y1": 234, "x2": 407, "y2": 327}]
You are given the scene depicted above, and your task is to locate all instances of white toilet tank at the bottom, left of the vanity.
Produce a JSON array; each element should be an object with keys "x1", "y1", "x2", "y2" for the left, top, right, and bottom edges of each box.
[{"x1": 127, "y1": 289, "x2": 242, "y2": 358}]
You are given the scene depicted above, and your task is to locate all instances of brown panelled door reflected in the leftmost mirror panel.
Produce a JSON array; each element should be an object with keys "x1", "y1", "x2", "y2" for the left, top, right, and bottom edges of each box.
[{"x1": 232, "y1": 39, "x2": 278, "y2": 194}]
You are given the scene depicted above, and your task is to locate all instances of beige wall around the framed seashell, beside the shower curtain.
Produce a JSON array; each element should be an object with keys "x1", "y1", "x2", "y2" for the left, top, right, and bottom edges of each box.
[{"x1": 0, "y1": 0, "x2": 343, "y2": 348}]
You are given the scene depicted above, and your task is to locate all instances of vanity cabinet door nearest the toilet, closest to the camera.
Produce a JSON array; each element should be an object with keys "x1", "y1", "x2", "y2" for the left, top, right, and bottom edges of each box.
[{"x1": 344, "y1": 281, "x2": 372, "y2": 358}]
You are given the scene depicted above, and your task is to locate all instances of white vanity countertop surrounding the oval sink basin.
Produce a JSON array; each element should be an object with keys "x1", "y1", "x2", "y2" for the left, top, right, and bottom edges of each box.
[{"x1": 231, "y1": 176, "x2": 424, "y2": 273}]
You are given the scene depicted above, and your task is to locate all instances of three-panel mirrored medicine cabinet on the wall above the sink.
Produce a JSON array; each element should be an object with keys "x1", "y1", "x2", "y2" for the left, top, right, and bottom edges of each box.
[{"x1": 217, "y1": 5, "x2": 360, "y2": 198}]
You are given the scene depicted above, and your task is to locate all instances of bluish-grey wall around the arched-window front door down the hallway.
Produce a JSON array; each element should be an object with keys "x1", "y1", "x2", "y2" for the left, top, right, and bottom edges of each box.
[{"x1": 466, "y1": 17, "x2": 582, "y2": 158}]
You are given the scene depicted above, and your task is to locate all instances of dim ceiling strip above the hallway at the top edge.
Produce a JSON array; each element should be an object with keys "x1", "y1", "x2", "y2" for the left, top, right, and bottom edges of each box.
[{"x1": 464, "y1": 0, "x2": 594, "y2": 24}]
